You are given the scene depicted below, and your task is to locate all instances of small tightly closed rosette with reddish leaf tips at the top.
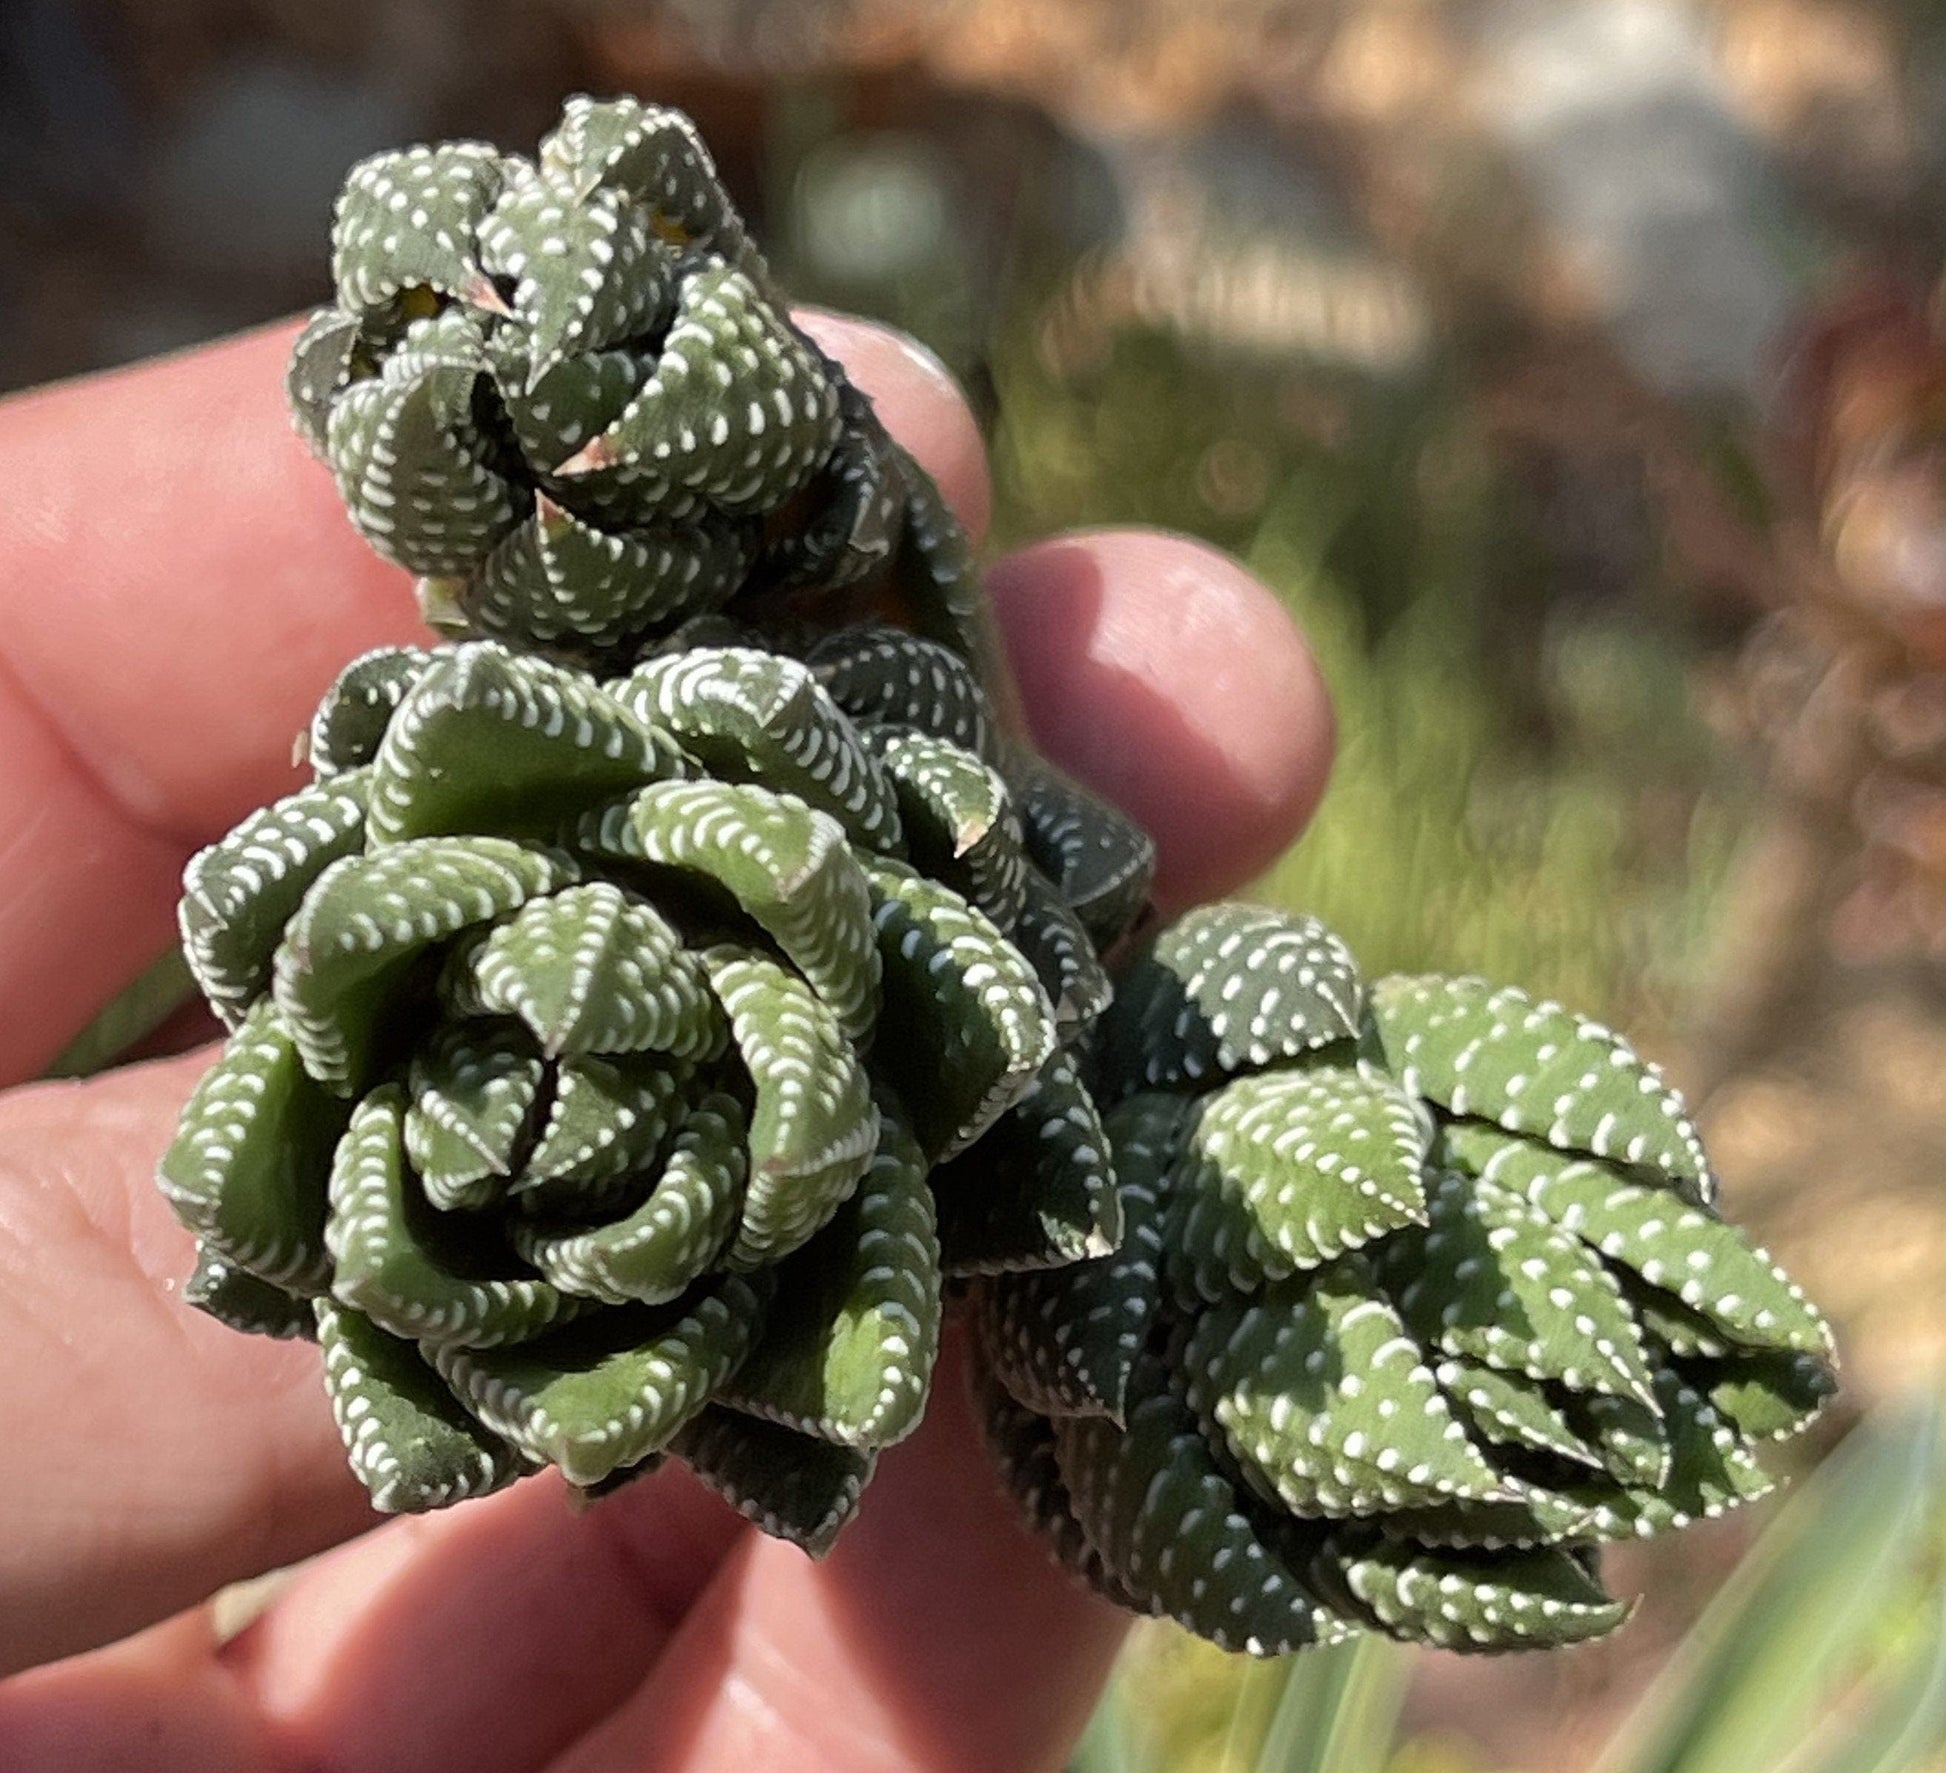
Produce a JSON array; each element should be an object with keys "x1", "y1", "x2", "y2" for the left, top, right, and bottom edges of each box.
[{"x1": 288, "y1": 97, "x2": 977, "y2": 656}]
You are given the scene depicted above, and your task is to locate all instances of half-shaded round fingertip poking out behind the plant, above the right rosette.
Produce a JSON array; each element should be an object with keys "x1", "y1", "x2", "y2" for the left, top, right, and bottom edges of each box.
[{"x1": 989, "y1": 529, "x2": 1333, "y2": 911}]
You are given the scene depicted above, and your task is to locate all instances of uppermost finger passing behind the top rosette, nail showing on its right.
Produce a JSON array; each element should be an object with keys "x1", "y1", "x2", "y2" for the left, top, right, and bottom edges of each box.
[{"x1": 0, "y1": 315, "x2": 987, "y2": 1082}]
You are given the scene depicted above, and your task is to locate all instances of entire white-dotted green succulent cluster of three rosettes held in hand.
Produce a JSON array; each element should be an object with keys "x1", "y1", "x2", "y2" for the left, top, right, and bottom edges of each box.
[{"x1": 162, "y1": 99, "x2": 1831, "y2": 1650}]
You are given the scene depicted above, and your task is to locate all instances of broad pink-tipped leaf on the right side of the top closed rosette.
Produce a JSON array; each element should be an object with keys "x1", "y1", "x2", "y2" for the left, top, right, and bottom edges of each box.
[{"x1": 555, "y1": 265, "x2": 839, "y2": 512}]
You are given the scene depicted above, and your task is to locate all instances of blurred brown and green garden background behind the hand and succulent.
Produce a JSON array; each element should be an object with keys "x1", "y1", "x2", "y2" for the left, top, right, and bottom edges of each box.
[{"x1": 11, "y1": 0, "x2": 1946, "y2": 1773}]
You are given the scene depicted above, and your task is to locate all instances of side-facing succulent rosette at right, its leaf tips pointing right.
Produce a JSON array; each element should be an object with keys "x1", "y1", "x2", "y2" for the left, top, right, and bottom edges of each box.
[{"x1": 975, "y1": 905, "x2": 1835, "y2": 1652}]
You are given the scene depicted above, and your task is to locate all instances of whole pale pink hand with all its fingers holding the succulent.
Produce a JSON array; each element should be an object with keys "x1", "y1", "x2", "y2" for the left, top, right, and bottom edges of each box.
[{"x1": 0, "y1": 315, "x2": 1331, "y2": 1773}]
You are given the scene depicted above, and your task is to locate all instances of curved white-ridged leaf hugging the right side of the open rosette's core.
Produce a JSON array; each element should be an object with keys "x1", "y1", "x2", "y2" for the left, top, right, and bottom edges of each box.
[{"x1": 703, "y1": 946, "x2": 880, "y2": 1267}]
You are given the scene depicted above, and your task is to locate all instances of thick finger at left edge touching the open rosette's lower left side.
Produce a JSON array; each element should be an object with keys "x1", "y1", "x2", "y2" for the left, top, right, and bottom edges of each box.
[{"x1": 0, "y1": 1055, "x2": 372, "y2": 1672}]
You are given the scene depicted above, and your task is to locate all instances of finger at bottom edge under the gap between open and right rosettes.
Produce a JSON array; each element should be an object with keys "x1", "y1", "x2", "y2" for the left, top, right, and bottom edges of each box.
[{"x1": 555, "y1": 1337, "x2": 1127, "y2": 1773}]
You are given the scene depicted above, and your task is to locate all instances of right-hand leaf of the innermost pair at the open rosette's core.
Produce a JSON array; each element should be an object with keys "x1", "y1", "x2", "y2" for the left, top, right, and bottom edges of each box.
[{"x1": 514, "y1": 1053, "x2": 691, "y2": 1214}]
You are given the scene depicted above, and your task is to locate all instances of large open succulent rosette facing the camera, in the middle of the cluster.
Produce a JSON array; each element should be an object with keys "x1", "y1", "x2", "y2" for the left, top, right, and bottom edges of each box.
[{"x1": 162, "y1": 629, "x2": 1148, "y2": 1551}]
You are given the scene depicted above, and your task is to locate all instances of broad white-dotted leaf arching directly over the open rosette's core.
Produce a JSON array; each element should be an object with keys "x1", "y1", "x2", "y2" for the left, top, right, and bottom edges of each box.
[{"x1": 442, "y1": 880, "x2": 726, "y2": 1059}]
